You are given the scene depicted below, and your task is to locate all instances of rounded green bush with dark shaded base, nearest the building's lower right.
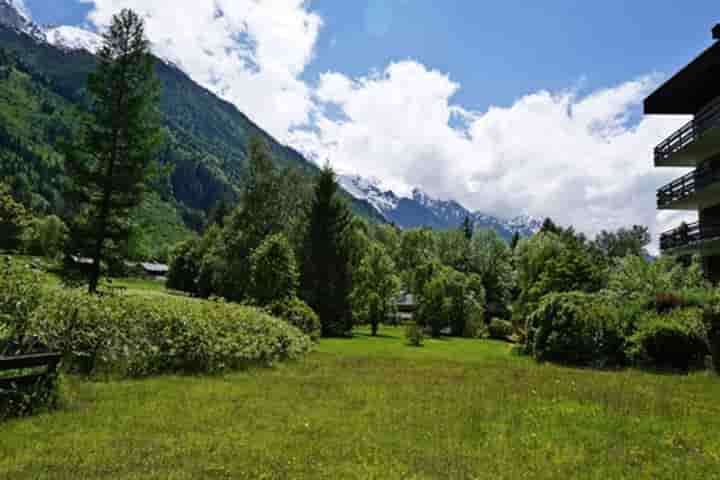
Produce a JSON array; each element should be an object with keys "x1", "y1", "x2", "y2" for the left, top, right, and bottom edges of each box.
[{"x1": 628, "y1": 308, "x2": 710, "y2": 370}]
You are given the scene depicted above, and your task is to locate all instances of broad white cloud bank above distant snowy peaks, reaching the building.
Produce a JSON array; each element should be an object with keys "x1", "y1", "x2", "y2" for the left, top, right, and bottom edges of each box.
[{"x1": 294, "y1": 61, "x2": 686, "y2": 251}]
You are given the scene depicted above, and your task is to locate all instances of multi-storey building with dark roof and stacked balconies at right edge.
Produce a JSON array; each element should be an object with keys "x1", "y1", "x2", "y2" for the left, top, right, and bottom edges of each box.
[{"x1": 645, "y1": 25, "x2": 720, "y2": 282}]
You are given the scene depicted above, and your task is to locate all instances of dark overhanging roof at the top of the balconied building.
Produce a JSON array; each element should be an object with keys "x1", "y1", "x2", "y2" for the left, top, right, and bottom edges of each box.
[{"x1": 645, "y1": 34, "x2": 720, "y2": 115}]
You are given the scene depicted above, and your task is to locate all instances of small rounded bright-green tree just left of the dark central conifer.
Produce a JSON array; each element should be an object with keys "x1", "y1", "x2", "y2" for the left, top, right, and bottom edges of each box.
[{"x1": 250, "y1": 233, "x2": 299, "y2": 306}]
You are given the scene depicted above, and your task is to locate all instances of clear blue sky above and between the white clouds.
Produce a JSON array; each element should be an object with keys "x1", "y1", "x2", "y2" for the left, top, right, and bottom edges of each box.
[{"x1": 26, "y1": 0, "x2": 720, "y2": 110}]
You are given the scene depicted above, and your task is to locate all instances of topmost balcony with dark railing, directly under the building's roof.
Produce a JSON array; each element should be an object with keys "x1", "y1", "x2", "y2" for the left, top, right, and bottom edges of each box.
[{"x1": 655, "y1": 97, "x2": 720, "y2": 167}]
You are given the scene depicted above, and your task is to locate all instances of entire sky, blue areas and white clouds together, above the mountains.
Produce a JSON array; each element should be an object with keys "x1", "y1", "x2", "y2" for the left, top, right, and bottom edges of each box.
[{"x1": 19, "y1": 0, "x2": 720, "y2": 248}]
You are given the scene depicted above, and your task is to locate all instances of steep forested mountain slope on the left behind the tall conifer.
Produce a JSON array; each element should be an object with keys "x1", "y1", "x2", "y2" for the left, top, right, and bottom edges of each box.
[{"x1": 0, "y1": 0, "x2": 381, "y2": 255}]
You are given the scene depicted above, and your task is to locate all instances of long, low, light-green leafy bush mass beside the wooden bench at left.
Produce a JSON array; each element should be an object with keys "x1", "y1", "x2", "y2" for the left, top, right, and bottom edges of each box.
[{"x1": 29, "y1": 290, "x2": 311, "y2": 376}]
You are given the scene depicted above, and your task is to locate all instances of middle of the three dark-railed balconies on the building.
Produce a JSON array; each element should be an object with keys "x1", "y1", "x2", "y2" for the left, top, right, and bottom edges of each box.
[{"x1": 657, "y1": 164, "x2": 720, "y2": 210}]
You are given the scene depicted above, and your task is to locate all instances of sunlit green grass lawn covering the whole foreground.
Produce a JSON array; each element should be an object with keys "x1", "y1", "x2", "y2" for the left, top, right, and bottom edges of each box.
[{"x1": 0, "y1": 329, "x2": 720, "y2": 480}]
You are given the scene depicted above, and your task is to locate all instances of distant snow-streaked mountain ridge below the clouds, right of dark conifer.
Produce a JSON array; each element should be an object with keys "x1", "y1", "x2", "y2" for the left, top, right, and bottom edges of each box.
[{"x1": 338, "y1": 175, "x2": 543, "y2": 240}]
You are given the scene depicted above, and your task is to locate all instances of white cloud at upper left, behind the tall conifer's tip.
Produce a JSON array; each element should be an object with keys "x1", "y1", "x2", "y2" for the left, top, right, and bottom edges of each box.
[{"x1": 83, "y1": 0, "x2": 322, "y2": 140}]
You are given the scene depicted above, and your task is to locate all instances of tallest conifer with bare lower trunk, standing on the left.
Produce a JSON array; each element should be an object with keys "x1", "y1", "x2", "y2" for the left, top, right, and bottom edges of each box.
[{"x1": 66, "y1": 9, "x2": 162, "y2": 293}]
